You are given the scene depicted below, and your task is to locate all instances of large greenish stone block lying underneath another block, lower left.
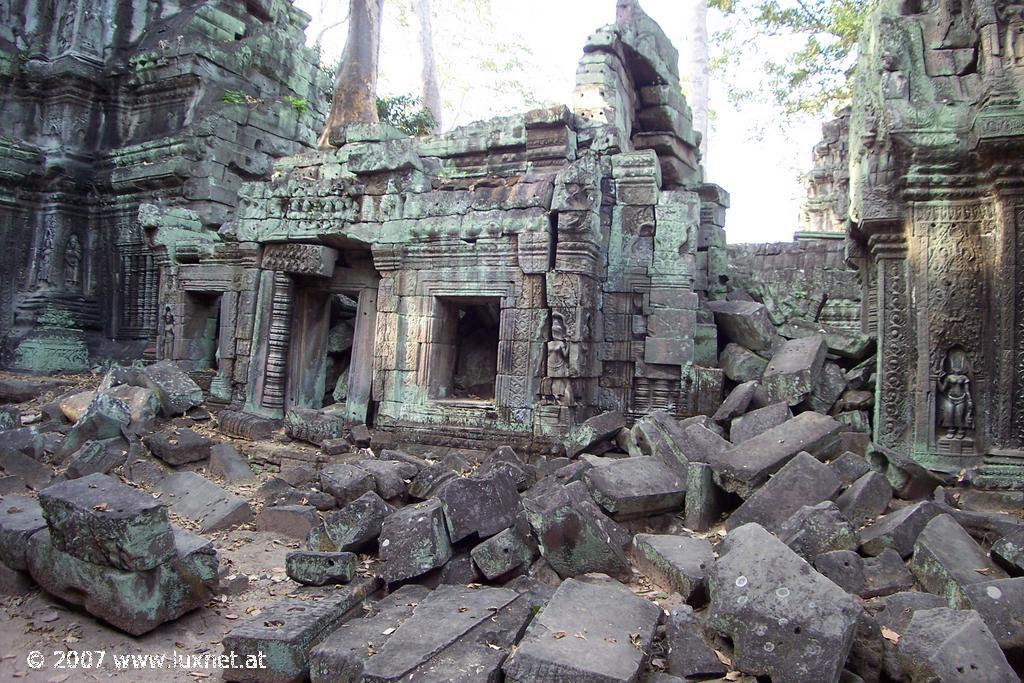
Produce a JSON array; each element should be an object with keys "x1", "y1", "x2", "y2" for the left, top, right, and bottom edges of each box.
[{"x1": 27, "y1": 528, "x2": 217, "y2": 636}]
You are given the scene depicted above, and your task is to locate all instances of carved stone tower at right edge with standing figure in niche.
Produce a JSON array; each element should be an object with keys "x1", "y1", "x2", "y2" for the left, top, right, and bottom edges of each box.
[{"x1": 849, "y1": 0, "x2": 1024, "y2": 485}]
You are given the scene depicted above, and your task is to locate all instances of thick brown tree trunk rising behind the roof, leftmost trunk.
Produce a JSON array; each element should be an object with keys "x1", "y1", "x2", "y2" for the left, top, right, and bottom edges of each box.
[{"x1": 318, "y1": 0, "x2": 384, "y2": 148}]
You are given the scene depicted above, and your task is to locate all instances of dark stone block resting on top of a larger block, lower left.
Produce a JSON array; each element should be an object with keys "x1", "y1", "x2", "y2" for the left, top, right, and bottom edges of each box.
[{"x1": 39, "y1": 474, "x2": 175, "y2": 571}]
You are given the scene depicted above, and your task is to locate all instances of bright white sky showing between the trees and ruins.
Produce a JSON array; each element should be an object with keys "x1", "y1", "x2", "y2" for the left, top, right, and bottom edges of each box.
[{"x1": 295, "y1": 0, "x2": 820, "y2": 243}]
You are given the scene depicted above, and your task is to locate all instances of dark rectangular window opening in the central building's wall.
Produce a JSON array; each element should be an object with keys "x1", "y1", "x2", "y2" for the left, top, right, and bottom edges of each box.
[{"x1": 429, "y1": 297, "x2": 501, "y2": 401}]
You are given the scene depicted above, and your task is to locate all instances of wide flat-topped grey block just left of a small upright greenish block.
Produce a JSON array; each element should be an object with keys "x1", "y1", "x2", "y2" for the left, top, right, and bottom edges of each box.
[{"x1": 583, "y1": 456, "x2": 686, "y2": 521}]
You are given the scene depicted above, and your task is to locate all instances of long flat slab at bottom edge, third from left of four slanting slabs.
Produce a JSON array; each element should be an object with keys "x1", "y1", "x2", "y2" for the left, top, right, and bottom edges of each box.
[{"x1": 362, "y1": 586, "x2": 518, "y2": 683}]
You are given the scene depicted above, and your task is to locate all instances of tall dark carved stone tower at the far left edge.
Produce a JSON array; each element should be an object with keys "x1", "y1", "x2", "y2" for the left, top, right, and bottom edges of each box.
[{"x1": 0, "y1": 0, "x2": 325, "y2": 371}]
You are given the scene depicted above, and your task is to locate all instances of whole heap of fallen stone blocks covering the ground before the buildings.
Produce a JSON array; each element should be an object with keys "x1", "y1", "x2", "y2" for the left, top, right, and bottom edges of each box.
[{"x1": 0, "y1": 358, "x2": 1024, "y2": 683}]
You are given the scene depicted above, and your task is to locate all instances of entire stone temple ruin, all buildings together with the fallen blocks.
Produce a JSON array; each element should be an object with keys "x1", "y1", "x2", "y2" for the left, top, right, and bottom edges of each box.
[{"x1": 0, "y1": 0, "x2": 1024, "y2": 683}]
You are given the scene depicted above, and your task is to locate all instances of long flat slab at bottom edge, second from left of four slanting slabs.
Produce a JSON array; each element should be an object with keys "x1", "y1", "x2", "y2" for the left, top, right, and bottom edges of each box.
[{"x1": 309, "y1": 584, "x2": 431, "y2": 683}]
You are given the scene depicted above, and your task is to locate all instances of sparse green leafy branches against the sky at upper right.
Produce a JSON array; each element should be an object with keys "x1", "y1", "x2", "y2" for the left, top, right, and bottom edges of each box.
[{"x1": 708, "y1": 0, "x2": 878, "y2": 116}]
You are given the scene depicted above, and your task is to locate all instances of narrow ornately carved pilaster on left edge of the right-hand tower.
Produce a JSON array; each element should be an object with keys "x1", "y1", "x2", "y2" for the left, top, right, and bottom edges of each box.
[{"x1": 869, "y1": 233, "x2": 913, "y2": 453}]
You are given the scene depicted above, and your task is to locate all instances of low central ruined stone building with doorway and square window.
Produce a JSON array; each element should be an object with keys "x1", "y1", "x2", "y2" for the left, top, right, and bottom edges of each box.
[{"x1": 143, "y1": 0, "x2": 728, "y2": 446}]
